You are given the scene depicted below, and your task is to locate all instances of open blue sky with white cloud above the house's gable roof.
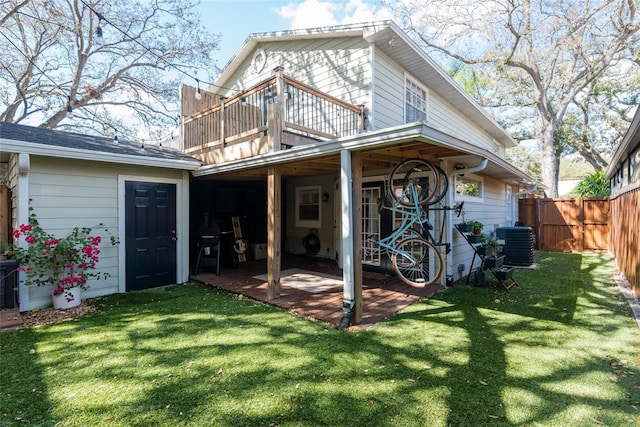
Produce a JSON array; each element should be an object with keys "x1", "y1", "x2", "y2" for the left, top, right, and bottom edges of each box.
[{"x1": 199, "y1": 0, "x2": 390, "y2": 74}]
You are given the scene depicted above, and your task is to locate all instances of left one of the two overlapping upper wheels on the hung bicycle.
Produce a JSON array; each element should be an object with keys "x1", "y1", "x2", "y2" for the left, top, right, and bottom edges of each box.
[{"x1": 387, "y1": 159, "x2": 440, "y2": 206}]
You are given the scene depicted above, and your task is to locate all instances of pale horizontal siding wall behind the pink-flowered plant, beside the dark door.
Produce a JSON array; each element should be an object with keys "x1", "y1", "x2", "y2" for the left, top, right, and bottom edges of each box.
[{"x1": 21, "y1": 156, "x2": 182, "y2": 309}]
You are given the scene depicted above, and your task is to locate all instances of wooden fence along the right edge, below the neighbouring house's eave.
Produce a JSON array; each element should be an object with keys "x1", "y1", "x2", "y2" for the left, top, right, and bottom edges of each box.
[{"x1": 609, "y1": 188, "x2": 640, "y2": 298}]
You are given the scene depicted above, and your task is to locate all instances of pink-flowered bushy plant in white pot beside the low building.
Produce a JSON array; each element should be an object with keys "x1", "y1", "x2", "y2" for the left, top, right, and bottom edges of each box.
[{"x1": 9, "y1": 206, "x2": 118, "y2": 308}]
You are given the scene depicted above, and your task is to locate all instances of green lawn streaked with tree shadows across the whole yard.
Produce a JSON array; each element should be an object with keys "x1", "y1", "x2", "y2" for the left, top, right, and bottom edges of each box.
[{"x1": 0, "y1": 253, "x2": 640, "y2": 426}]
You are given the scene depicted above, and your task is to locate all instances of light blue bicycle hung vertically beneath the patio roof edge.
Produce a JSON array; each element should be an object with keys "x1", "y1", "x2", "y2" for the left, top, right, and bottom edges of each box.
[{"x1": 377, "y1": 159, "x2": 462, "y2": 288}]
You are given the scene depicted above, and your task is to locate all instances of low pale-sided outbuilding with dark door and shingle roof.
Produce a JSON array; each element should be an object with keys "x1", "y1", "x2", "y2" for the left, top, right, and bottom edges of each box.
[{"x1": 0, "y1": 123, "x2": 201, "y2": 311}]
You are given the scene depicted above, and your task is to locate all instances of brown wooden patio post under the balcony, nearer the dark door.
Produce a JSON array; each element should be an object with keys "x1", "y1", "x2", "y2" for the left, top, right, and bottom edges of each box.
[{"x1": 267, "y1": 166, "x2": 282, "y2": 301}]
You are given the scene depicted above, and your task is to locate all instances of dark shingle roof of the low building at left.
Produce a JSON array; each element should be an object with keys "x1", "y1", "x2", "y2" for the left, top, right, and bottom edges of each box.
[{"x1": 0, "y1": 122, "x2": 198, "y2": 166}]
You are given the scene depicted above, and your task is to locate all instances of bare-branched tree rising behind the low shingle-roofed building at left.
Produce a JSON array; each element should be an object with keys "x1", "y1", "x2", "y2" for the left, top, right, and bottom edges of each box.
[{"x1": 0, "y1": 0, "x2": 219, "y2": 142}]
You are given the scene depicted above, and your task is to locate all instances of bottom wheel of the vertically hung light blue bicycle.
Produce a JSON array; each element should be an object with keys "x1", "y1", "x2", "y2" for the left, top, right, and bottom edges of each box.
[{"x1": 391, "y1": 237, "x2": 444, "y2": 288}]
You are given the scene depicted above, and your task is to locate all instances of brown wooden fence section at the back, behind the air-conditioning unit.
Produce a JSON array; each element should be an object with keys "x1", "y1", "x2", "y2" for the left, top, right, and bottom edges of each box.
[{"x1": 518, "y1": 197, "x2": 609, "y2": 252}]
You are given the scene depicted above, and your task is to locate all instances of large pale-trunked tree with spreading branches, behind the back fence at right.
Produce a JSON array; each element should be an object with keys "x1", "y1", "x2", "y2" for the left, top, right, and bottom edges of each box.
[{"x1": 387, "y1": 0, "x2": 640, "y2": 196}]
